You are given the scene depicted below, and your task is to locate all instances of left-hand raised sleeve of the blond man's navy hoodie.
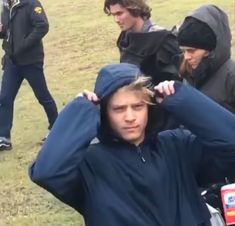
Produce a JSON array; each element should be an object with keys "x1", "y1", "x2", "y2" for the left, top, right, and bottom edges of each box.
[{"x1": 29, "y1": 97, "x2": 100, "y2": 211}]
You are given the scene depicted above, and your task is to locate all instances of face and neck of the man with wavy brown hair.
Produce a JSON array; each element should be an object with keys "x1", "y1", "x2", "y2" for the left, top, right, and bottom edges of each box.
[{"x1": 110, "y1": 4, "x2": 143, "y2": 32}]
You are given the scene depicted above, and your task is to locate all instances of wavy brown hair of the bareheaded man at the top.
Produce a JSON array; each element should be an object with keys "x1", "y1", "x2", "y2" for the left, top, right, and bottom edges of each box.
[{"x1": 104, "y1": 0, "x2": 152, "y2": 19}]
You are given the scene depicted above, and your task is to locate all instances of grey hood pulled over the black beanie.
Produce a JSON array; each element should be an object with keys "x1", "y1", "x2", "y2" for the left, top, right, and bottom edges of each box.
[{"x1": 186, "y1": 5, "x2": 232, "y2": 72}]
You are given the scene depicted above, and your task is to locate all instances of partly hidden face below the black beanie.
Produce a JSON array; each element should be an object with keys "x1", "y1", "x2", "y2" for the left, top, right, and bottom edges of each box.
[{"x1": 180, "y1": 46, "x2": 209, "y2": 69}]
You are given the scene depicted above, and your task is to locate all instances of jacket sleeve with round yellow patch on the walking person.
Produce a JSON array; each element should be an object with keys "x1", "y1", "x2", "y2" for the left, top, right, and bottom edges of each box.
[{"x1": 16, "y1": 0, "x2": 49, "y2": 54}]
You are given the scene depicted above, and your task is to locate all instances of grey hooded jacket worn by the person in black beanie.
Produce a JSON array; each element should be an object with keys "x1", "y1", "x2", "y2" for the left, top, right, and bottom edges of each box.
[{"x1": 184, "y1": 5, "x2": 235, "y2": 113}]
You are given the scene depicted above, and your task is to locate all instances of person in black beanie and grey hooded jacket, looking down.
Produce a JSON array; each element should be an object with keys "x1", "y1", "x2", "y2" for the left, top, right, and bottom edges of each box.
[{"x1": 177, "y1": 5, "x2": 235, "y2": 113}]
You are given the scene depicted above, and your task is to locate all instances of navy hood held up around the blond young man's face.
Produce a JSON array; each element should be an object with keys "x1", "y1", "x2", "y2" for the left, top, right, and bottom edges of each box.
[{"x1": 94, "y1": 63, "x2": 162, "y2": 142}]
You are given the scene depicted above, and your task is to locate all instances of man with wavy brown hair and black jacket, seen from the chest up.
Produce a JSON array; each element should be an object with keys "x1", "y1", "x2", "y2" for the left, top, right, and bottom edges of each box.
[{"x1": 104, "y1": 0, "x2": 180, "y2": 84}]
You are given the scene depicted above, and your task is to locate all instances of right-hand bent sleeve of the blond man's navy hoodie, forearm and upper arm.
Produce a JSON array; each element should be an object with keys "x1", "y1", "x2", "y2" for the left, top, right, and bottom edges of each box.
[{"x1": 163, "y1": 82, "x2": 235, "y2": 184}]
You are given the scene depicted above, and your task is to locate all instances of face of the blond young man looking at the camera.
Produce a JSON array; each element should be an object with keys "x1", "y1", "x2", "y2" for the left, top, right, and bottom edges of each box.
[{"x1": 107, "y1": 88, "x2": 148, "y2": 145}]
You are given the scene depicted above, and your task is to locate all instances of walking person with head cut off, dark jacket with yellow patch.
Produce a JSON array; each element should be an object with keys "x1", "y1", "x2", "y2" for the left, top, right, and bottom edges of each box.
[{"x1": 0, "y1": 0, "x2": 57, "y2": 151}]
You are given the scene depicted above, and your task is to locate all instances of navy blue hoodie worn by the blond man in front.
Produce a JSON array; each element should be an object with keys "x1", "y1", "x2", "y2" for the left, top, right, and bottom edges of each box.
[{"x1": 29, "y1": 63, "x2": 235, "y2": 226}]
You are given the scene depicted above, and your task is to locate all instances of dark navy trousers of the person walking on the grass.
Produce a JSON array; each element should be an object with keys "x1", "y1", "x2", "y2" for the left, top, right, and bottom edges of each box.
[{"x1": 0, "y1": 60, "x2": 58, "y2": 138}]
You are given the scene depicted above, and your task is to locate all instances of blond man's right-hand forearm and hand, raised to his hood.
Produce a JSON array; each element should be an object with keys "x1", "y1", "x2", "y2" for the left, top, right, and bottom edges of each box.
[{"x1": 157, "y1": 82, "x2": 235, "y2": 149}]
